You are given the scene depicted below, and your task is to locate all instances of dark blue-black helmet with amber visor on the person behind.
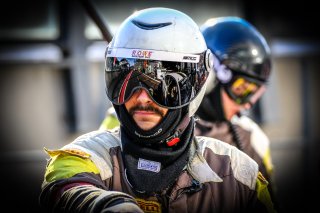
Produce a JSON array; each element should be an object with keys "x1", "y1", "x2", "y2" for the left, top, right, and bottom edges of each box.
[{"x1": 200, "y1": 17, "x2": 271, "y2": 104}]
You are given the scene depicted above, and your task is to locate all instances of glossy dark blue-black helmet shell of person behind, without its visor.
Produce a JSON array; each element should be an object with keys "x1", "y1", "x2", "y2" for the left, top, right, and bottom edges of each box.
[{"x1": 201, "y1": 17, "x2": 271, "y2": 82}]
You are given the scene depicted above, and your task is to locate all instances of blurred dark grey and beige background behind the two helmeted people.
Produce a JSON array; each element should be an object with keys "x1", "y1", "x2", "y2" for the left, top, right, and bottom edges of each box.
[{"x1": 0, "y1": 0, "x2": 320, "y2": 212}]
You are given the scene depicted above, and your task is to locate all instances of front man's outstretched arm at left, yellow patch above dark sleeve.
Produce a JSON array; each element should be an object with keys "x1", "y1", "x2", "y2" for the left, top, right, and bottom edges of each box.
[{"x1": 40, "y1": 150, "x2": 142, "y2": 212}]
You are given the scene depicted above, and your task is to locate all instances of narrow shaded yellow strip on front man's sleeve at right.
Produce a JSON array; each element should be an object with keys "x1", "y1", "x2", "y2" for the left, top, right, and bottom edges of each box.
[{"x1": 256, "y1": 172, "x2": 276, "y2": 212}]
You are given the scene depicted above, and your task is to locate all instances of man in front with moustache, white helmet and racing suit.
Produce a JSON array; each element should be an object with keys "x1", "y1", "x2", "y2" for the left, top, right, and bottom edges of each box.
[{"x1": 40, "y1": 8, "x2": 273, "y2": 212}]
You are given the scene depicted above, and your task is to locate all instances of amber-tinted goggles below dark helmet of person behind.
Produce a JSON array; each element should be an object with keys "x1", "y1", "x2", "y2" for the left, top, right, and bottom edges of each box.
[{"x1": 226, "y1": 76, "x2": 266, "y2": 105}]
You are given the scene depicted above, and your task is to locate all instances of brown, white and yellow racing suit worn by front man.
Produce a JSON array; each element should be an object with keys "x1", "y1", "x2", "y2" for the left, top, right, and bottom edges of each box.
[{"x1": 40, "y1": 129, "x2": 274, "y2": 212}]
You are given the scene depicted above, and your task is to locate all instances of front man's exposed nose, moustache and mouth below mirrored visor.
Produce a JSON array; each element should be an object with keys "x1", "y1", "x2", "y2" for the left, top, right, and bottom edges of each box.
[{"x1": 125, "y1": 89, "x2": 168, "y2": 130}]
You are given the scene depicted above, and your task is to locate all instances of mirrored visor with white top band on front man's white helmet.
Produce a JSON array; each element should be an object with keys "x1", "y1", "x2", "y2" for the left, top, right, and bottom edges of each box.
[{"x1": 105, "y1": 48, "x2": 209, "y2": 109}]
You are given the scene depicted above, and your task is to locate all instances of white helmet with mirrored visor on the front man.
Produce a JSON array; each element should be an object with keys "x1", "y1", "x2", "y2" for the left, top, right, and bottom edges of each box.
[{"x1": 105, "y1": 8, "x2": 213, "y2": 116}]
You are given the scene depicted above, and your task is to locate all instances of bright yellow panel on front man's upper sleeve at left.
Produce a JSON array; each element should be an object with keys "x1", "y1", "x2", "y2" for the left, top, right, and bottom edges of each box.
[{"x1": 45, "y1": 150, "x2": 99, "y2": 182}]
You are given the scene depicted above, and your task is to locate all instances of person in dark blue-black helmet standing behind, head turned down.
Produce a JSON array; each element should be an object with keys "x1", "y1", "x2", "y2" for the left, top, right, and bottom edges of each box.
[{"x1": 195, "y1": 17, "x2": 273, "y2": 206}]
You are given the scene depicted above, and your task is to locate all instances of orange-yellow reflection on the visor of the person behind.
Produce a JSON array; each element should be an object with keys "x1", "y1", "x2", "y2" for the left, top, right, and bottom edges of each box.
[{"x1": 227, "y1": 77, "x2": 260, "y2": 104}]
